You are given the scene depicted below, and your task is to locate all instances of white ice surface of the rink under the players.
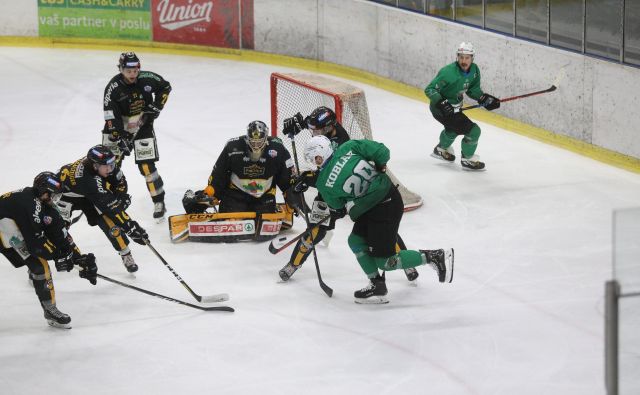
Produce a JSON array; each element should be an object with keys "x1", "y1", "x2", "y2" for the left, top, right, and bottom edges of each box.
[{"x1": 0, "y1": 47, "x2": 640, "y2": 395}]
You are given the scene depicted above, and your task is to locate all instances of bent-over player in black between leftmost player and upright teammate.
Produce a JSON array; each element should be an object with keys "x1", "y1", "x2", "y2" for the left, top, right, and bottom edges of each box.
[{"x1": 58, "y1": 145, "x2": 149, "y2": 273}]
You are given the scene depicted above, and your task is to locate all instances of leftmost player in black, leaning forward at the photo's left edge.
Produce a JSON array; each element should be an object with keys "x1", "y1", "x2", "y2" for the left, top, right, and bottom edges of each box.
[{"x1": 0, "y1": 172, "x2": 98, "y2": 328}]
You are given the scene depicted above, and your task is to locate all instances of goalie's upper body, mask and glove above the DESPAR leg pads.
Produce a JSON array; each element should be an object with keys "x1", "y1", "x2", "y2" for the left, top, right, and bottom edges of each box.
[{"x1": 183, "y1": 121, "x2": 294, "y2": 214}]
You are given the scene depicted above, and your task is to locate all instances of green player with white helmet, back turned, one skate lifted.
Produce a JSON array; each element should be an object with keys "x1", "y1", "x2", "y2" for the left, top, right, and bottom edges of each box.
[{"x1": 304, "y1": 135, "x2": 453, "y2": 303}]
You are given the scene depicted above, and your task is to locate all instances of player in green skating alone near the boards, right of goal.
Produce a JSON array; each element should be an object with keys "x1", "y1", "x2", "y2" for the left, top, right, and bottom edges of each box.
[{"x1": 424, "y1": 42, "x2": 500, "y2": 170}]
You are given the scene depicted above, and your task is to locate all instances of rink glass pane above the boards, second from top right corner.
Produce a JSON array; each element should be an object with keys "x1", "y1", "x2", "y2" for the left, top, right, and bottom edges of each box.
[{"x1": 585, "y1": 0, "x2": 622, "y2": 60}]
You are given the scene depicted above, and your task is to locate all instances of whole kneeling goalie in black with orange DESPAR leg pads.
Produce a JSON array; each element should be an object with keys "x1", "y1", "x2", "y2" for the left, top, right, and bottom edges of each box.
[{"x1": 176, "y1": 121, "x2": 293, "y2": 242}]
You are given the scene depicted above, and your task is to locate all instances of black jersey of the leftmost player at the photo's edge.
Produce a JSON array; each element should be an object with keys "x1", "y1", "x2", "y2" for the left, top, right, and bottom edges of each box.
[{"x1": 0, "y1": 187, "x2": 73, "y2": 260}]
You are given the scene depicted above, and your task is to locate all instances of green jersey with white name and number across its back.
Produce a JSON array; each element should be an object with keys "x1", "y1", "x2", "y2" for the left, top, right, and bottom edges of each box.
[{"x1": 316, "y1": 140, "x2": 393, "y2": 221}]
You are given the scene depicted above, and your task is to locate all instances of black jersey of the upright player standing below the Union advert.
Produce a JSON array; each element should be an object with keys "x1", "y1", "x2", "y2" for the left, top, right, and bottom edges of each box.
[{"x1": 103, "y1": 71, "x2": 171, "y2": 137}]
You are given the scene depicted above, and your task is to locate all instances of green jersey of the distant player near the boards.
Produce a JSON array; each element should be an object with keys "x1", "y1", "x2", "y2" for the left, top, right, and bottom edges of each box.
[{"x1": 424, "y1": 62, "x2": 484, "y2": 113}]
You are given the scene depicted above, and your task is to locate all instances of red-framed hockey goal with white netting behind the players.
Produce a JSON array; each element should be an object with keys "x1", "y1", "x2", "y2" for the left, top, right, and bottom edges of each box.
[{"x1": 271, "y1": 73, "x2": 422, "y2": 211}]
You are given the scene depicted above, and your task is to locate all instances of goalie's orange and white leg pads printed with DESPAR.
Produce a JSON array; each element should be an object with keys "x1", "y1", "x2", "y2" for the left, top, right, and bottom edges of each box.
[{"x1": 169, "y1": 203, "x2": 293, "y2": 243}]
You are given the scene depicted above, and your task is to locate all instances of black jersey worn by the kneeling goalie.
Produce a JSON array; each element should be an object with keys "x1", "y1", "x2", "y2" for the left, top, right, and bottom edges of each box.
[{"x1": 209, "y1": 136, "x2": 293, "y2": 200}]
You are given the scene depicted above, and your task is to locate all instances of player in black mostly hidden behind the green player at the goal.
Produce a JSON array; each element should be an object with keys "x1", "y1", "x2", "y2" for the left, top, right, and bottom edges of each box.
[{"x1": 278, "y1": 106, "x2": 419, "y2": 281}]
